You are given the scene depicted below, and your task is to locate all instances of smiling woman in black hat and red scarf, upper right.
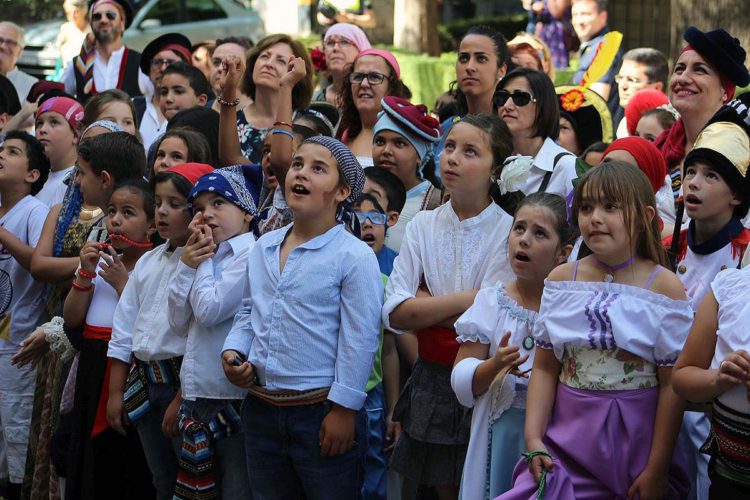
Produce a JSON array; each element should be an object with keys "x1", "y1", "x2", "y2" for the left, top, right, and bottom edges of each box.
[{"x1": 655, "y1": 26, "x2": 750, "y2": 198}]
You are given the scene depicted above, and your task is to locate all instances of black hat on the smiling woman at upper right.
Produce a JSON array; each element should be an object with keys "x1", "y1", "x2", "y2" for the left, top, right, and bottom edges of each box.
[{"x1": 683, "y1": 26, "x2": 750, "y2": 87}]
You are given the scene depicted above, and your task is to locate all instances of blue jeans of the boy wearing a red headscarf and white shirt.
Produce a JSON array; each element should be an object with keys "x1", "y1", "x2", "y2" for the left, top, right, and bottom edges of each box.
[{"x1": 133, "y1": 384, "x2": 181, "y2": 500}]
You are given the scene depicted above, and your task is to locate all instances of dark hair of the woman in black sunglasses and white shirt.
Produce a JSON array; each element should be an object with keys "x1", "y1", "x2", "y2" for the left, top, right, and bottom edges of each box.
[{"x1": 498, "y1": 68, "x2": 560, "y2": 140}]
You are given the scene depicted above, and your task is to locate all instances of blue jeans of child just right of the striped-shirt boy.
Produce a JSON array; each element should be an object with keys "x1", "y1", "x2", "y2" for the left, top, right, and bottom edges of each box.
[{"x1": 360, "y1": 384, "x2": 388, "y2": 500}]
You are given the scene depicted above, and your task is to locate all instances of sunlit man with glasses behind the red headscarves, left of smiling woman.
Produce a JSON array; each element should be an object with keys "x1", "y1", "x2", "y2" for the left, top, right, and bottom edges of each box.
[{"x1": 612, "y1": 48, "x2": 669, "y2": 139}]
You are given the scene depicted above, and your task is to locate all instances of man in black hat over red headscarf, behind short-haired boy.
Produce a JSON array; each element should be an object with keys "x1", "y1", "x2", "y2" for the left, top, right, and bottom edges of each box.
[{"x1": 133, "y1": 33, "x2": 193, "y2": 151}]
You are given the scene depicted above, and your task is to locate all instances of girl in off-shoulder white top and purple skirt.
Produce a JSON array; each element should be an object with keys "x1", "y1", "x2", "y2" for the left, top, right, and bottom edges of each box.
[{"x1": 499, "y1": 161, "x2": 692, "y2": 499}]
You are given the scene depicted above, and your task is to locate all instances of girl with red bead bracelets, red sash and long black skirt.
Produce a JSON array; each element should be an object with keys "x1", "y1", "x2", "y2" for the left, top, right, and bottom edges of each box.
[{"x1": 63, "y1": 178, "x2": 155, "y2": 500}]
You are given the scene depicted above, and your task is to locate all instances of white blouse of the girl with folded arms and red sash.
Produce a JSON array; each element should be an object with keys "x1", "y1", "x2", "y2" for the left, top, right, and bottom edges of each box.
[{"x1": 382, "y1": 203, "x2": 513, "y2": 333}]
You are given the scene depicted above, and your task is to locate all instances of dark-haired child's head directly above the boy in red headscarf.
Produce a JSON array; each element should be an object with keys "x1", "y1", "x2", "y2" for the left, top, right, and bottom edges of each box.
[{"x1": 149, "y1": 127, "x2": 211, "y2": 177}]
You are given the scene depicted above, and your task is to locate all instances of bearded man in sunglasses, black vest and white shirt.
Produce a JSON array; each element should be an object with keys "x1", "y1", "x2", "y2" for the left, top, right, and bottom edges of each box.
[{"x1": 62, "y1": 0, "x2": 151, "y2": 102}]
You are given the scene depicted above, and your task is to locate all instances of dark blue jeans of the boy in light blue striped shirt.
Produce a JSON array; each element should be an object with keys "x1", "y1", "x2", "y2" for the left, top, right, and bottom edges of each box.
[{"x1": 242, "y1": 396, "x2": 365, "y2": 500}]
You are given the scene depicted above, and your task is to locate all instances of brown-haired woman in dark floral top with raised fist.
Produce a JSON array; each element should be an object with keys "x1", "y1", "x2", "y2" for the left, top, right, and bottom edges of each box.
[{"x1": 217, "y1": 35, "x2": 312, "y2": 165}]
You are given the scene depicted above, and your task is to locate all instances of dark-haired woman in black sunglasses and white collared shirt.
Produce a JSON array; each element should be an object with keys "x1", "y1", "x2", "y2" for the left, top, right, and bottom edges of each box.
[{"x1": 502, "y1": 68, "x2": 577, "y2": 197}]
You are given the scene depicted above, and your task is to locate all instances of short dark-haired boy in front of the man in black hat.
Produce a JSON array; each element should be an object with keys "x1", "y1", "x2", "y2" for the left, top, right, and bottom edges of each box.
[{"x1": 159, "y1": 61, "x2": 214, "y2": 120}]
